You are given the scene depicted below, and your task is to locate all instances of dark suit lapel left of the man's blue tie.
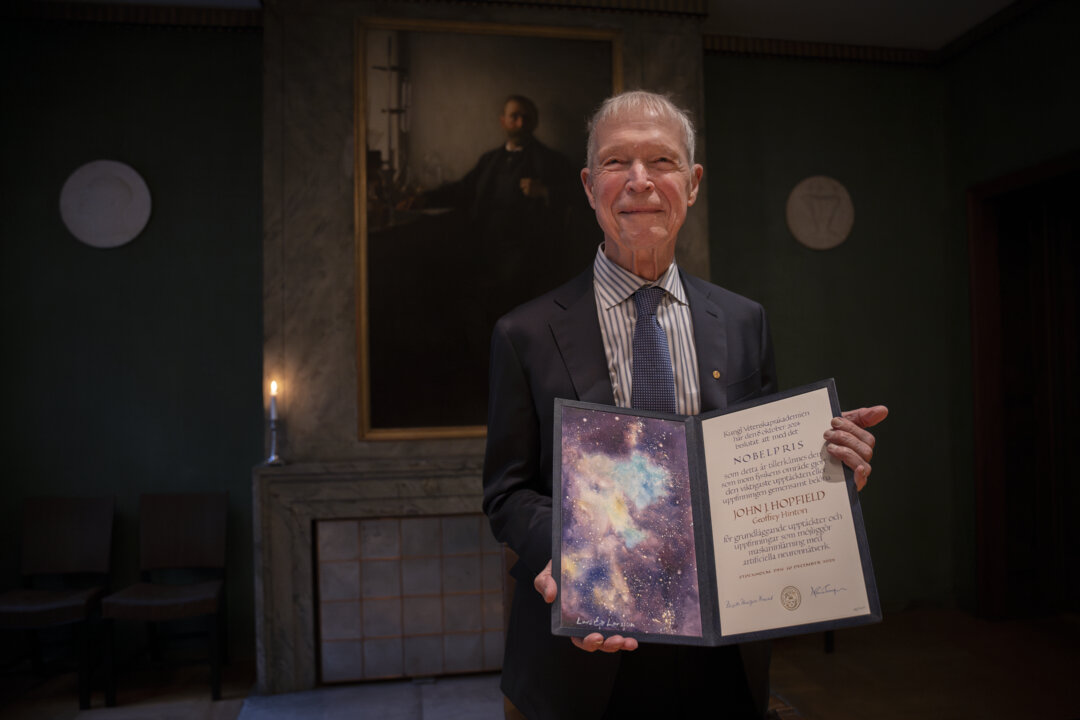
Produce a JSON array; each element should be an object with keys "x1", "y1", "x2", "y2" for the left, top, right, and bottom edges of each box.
[{"x1": 551, "y1": 266, "x2": 615, "y2": 405}]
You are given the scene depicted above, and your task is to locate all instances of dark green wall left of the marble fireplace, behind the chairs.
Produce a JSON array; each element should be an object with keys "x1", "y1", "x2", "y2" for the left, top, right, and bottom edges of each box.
[{"x1": 0, "y1": 22, "x2": 262, "y2": 654}]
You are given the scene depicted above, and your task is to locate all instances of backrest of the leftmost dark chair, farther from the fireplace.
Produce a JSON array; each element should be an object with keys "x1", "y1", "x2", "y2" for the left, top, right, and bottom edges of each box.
[{"x1": 22, "y1": 497, "x2": 116, "y2": 575}]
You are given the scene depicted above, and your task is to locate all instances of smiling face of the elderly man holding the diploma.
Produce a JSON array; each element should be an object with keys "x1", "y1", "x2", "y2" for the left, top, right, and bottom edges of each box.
[{"x1": 581, "y1": 116, "x2": 702, "y2": 274}]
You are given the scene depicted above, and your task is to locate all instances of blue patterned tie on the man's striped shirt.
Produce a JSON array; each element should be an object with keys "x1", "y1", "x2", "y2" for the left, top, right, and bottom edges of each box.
[{"x1": 630, "y1": 287, "x2": 675, "y2": 412}]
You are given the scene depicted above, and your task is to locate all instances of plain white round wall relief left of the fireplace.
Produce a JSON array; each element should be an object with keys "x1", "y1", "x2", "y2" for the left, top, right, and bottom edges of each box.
[{"x1": 60, "y1": 160, "x2": 150, "y2": 247}]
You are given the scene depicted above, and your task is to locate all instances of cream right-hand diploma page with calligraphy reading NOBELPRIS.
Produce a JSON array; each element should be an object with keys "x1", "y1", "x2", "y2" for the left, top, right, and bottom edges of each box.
[{"x1": 702, "y1": 388, "x2": 868, "y2": 635}]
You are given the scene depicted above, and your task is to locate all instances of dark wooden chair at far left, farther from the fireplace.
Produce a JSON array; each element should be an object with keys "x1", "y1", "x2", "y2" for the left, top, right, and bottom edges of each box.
[{"x1": 0, "y1": 498, "x2": 116, "y2": 709}]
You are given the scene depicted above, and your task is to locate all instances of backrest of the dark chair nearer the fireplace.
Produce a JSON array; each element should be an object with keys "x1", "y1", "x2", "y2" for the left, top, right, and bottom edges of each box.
[{"x1": 138, "y1": 492, "x2": 229, "y2": 571}]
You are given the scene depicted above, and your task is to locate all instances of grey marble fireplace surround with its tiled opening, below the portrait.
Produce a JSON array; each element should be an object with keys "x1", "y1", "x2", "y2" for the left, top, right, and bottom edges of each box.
[{"x1": 254, "y1": 456, "x2": 492, "y2": 693}]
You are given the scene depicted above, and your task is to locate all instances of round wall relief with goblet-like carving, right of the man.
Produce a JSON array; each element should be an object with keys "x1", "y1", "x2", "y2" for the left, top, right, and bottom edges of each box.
[{"x1": 787, "y1": 175, "x2": 855, "y2": 250}]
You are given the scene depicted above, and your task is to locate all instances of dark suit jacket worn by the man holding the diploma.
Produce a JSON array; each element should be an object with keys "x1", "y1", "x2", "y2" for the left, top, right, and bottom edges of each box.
[{"x1": 484, "y1": 267, "x2": 777, "y2": 720}]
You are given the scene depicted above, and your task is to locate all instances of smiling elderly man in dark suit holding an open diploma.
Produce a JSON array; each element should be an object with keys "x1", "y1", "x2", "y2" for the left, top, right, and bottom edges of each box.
[{"x1": 484, "y1": 92, "x2": 888, "y2": 720}]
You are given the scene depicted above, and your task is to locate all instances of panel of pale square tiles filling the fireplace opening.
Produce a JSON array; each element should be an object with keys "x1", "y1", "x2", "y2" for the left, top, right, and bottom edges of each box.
[{"x1": 315, "y1": 515, "x2": 502, "y2": 682}]
